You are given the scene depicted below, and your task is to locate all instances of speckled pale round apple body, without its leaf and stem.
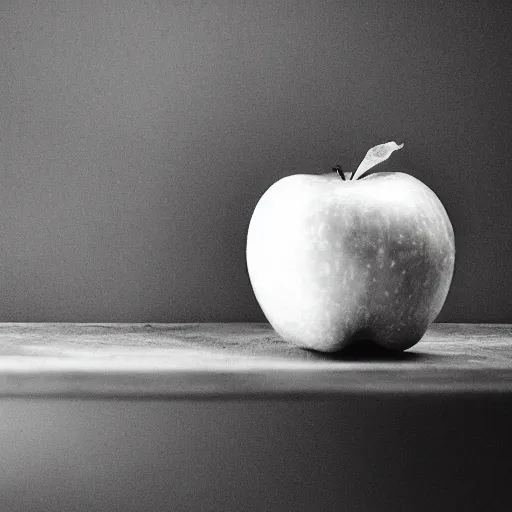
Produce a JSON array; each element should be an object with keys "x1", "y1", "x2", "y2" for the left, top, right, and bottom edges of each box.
[{"x1": 246, "y1": 172, "x2": 455, "y2": 352}]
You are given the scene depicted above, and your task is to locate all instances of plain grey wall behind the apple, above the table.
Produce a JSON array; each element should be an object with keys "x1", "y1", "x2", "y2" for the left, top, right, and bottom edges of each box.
[{"x1": 0, "y1": 0, "x2": 512, "y2": 322}]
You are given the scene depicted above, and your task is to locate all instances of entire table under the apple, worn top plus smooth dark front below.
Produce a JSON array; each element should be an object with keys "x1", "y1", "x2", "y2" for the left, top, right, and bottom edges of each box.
[{"x1": 0, "y1": 323, "x2": 512, "y2": 512}]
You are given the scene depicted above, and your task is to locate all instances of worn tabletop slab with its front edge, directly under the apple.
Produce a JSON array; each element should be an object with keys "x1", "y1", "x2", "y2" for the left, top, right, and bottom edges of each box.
[{"x1": 0, "y1": 323, "x2": 512, "y2": 398}]
